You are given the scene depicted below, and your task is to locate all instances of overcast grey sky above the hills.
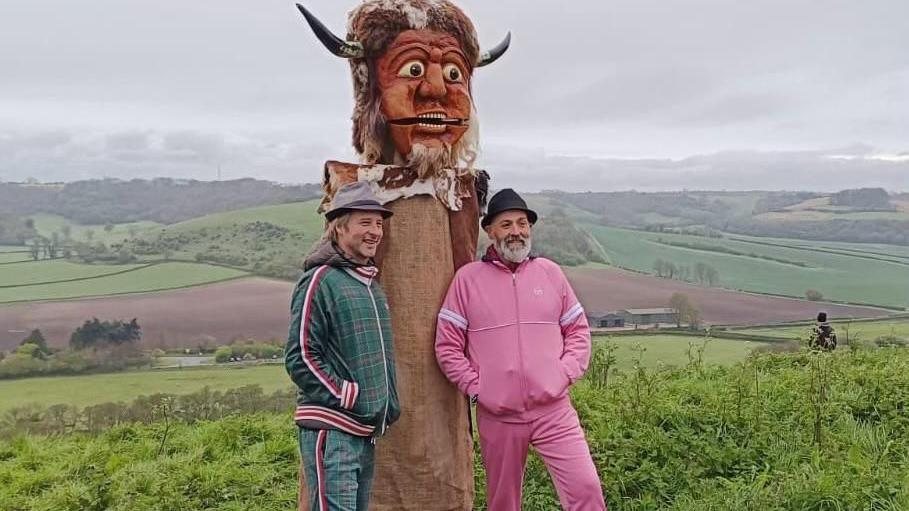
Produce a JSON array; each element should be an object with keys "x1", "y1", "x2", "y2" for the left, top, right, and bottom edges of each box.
[{"x1": 0, "y1": 0, "x2": 909, "y2": 190}]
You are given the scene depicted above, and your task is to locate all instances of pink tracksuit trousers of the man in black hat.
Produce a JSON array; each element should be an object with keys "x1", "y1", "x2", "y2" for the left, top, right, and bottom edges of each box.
[{"x1": 477, "y1": 399, "x2": 606, "y2": 511}]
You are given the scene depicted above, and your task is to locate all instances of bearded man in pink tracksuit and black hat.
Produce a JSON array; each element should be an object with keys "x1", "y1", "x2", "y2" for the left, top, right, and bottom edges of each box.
[{"x1": 436, "y1": 189, "x2": 606, "y2": 511}]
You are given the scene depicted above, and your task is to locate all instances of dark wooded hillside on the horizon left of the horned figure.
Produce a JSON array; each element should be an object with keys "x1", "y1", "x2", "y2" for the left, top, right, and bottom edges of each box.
[{"x1": 0, "y1": 178, "x2": 320, "y2": 224}]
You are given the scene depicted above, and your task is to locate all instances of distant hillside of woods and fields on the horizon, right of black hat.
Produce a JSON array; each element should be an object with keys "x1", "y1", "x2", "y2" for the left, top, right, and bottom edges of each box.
[{"x1": 543, "y1": 188, "x2": 909, "y2": 245}]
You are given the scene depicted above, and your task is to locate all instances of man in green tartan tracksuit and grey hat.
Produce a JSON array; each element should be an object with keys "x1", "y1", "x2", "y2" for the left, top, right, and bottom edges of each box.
[{"x1": 285, "y1": 183, "x2": 400, "y2": 511}]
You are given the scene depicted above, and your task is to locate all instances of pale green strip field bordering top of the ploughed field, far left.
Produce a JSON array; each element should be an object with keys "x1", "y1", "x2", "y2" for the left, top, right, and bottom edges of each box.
[{"x1": 0, "y1": 262, "x2": 247, "y2": 303}]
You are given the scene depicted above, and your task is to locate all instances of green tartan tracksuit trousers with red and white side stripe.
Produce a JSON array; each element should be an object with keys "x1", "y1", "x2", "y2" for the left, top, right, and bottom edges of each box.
[{"x1": 299, "y1": 428, "x2": 375, "y2": 511}]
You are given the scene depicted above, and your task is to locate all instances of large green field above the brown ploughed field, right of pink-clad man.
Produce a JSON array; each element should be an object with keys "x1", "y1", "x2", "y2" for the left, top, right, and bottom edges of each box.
[{"x1": 585, "y1": 224, "x2": 909, "y2": 307}]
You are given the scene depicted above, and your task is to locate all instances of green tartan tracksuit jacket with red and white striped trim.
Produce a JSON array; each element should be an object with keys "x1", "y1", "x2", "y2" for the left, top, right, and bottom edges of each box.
[{"x1": 285, "y1": 258, "x2": 400, "y2": 437}]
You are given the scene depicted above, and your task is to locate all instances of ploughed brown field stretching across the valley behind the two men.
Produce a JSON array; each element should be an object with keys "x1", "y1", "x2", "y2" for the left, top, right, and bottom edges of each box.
[{"x1": 0, "y1": 269, "x2": 888, "y2": 351}]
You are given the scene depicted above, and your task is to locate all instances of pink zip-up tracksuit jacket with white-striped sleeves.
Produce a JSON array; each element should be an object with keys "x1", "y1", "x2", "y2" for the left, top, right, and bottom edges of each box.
[{"x1": 436, "y1": 256, "x2": 590, "y2": 422}]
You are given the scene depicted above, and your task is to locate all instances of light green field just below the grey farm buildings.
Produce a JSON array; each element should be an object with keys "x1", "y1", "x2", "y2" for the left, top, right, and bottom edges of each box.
[{"x1": 594, "y1": 335, "x2": 766, "y2": 370}]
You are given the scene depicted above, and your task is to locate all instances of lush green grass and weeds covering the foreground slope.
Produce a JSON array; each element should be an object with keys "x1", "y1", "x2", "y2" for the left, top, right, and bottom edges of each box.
[{"x1": 0, "y1": 348, "x2": 909, "y2": 511}]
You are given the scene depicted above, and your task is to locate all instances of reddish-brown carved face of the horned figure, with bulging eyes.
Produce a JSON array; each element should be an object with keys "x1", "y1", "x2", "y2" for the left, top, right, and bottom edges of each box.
[{"x1": 376, "y1": 30, "x2": 471, "y2": 156}]
